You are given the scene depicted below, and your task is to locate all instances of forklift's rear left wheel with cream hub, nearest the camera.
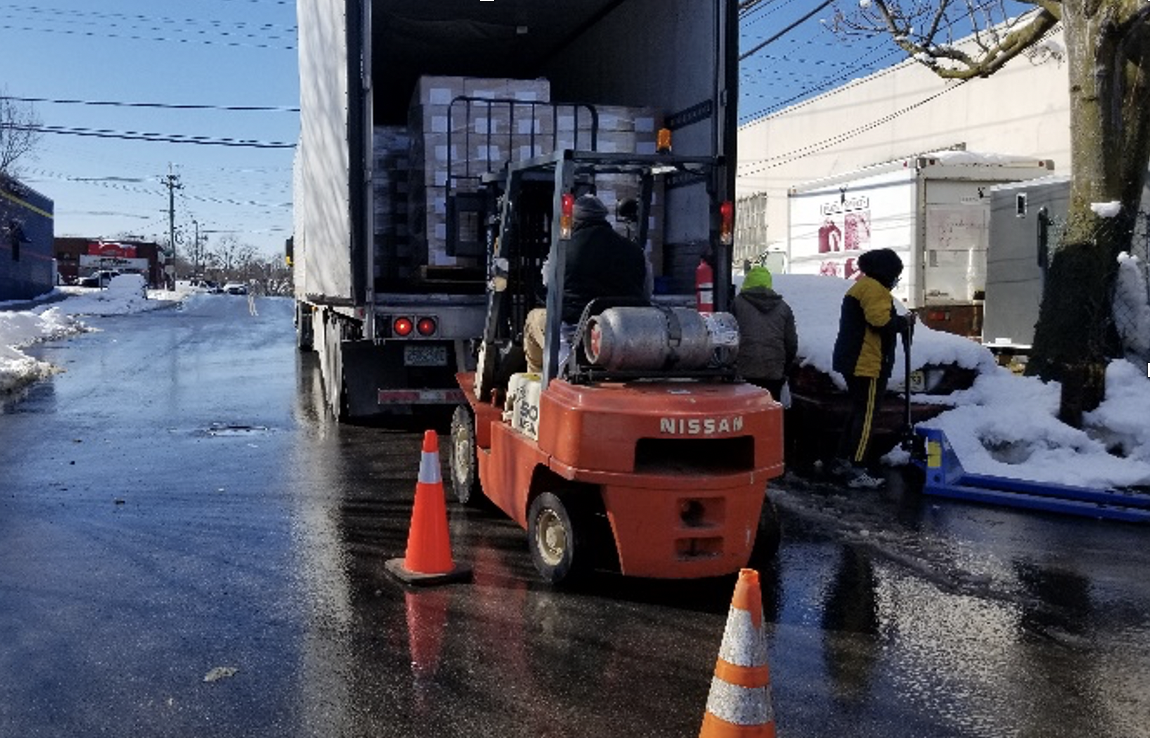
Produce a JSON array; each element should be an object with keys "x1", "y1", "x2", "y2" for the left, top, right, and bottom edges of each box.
[{"x1": 527, "y1": 492, "x2": 592, "y2": 584}]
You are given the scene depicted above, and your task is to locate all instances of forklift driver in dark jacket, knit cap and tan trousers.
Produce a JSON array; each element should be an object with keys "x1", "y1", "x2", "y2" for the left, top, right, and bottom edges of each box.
[{"x1": 523, "y1": 194, "x2": 651, "y2": 372}]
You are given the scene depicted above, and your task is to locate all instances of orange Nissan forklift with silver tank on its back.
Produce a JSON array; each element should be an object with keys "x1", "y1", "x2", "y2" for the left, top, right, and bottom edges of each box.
[{"x1": 450, "y1": 140, "x2": 783, "y2": 584}]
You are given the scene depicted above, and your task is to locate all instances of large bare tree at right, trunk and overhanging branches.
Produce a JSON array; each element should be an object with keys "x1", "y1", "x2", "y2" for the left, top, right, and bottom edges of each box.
[{"x1": 835, "y1": 0, "x2": 1150, "y2": 422}]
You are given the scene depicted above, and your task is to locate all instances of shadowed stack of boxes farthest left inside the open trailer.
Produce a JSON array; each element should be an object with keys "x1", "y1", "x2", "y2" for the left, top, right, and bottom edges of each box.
[{"x1": 371, "y1": 125, "x2": 419, "y2": 282}]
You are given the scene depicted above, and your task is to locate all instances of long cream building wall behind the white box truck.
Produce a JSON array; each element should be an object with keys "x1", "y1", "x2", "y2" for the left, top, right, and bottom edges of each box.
[{"x1": 735, "y1": 28, "x2": 1071, "y2": 263}]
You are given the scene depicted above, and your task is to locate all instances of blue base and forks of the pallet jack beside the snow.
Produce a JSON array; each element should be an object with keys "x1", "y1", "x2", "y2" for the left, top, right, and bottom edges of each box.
[{"x1": 914, "y1": 428, "x2": 1150, "y2": 523}]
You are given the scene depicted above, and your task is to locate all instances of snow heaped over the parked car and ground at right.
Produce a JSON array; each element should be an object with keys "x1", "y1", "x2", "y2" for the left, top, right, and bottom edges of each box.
[{"x1": 774, "y1": 275, "x2": 1150, "y2": 487}]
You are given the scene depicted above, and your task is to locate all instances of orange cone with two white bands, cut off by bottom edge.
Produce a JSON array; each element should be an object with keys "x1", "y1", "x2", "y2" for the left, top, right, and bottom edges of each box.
[{"x1": 699, "y1": 569, "x2": 775, "y2": 738}]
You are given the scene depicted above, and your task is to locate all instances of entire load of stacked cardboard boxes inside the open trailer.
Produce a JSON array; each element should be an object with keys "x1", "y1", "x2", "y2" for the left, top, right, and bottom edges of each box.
[{"x1": 373, "y1": 76, "x2": 662, "y2": 291}]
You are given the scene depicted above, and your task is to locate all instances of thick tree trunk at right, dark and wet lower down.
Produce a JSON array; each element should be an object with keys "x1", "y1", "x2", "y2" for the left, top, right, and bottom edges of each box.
[{"x1": 1027, "y1": 0, "x2": 1150, "y2": 425}]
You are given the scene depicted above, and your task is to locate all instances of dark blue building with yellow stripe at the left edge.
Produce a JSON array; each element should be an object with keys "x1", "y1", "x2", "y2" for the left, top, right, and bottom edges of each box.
[{"x1": 0, "y1": 176, "x2": 56, "y2": 301}]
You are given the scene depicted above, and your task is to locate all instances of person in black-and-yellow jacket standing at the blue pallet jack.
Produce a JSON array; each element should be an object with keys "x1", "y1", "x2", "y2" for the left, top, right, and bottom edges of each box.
[{"x1": 831, "y1": 248, "x2": 915, "y2": 487}]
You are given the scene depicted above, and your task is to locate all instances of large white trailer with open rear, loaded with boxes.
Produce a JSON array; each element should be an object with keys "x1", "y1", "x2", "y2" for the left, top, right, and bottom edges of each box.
[{"x1": 290, "y1": 0, "x2": 738, "y2": 418}]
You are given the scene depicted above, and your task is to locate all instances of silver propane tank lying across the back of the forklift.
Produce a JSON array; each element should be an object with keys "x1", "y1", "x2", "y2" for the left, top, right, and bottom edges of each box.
[{"x1": 583, "y1": 307, "x2": 738, "y2": 371}]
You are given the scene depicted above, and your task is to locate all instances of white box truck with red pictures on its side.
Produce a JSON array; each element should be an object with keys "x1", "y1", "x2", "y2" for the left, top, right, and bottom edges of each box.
[{"x1": 788, "y1": 151, "x2": 1053, "y2": 337}]
